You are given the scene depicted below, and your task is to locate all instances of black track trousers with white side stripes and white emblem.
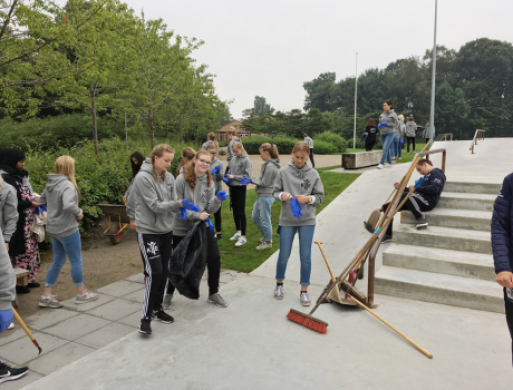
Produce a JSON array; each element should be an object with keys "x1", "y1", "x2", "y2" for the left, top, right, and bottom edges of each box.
[{"x1": 137, "y1": 232, "x2": 173, "y2": 319}]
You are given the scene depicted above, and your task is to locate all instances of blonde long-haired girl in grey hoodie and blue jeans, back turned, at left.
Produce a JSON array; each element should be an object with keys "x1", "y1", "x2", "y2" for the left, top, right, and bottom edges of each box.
[{"x1": 39, "y1": 156, "x2": 98, "y2": 309}]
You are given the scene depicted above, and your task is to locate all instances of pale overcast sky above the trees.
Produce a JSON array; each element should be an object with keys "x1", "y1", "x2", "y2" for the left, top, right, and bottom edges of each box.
[{"x1": 65, "y1": 0, "x2": 513, "y2": 118}]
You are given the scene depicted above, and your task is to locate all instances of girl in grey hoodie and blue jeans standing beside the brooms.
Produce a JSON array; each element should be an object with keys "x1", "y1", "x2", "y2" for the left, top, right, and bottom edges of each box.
[{"x1": 273, "y1": 142, "x2": 324, "y2": 306}]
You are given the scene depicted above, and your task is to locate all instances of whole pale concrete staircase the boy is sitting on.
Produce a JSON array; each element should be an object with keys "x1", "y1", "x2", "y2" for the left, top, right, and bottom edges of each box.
[{"x1": 375, "y1": 181, "x2": 504, "y2": 313}]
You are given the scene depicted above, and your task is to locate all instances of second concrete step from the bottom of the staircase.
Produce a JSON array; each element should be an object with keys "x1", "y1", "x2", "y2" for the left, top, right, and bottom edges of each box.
[{"x1": 383, "y1": 244, "x2": 495, "y2": 282}]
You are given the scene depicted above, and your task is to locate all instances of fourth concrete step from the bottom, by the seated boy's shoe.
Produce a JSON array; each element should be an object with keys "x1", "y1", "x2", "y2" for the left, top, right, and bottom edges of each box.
[{"x1": 401, "y1": 207, "x2": 492, "y2": 232}]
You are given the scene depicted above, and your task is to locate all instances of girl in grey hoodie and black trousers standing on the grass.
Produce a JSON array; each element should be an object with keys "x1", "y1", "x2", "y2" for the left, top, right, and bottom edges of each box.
[{"x1": 227, "y1": 142, "x2": 251, "y2": 246}]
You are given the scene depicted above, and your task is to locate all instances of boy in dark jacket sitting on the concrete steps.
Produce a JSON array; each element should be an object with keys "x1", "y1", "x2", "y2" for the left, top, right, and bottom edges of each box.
[{"x1": 381, "y1": 158, "x2": 445, "y2": 242}]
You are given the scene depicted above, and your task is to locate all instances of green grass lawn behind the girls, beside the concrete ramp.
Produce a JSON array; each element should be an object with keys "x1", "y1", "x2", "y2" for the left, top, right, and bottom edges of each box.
[{"x1": 219, "y1": 166, "x2": 359, "y2": 272}]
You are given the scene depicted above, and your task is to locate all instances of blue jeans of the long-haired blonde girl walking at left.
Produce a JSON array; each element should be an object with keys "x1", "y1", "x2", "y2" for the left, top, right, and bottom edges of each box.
[{"x1": 45, "y1": 230, "x2": 84, "y2": 288}]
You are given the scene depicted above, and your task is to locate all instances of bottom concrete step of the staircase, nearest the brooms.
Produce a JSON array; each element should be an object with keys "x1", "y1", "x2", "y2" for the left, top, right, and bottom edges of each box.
[{"x1": 375, "y1": 265, "x2": 504, "y2": 313}]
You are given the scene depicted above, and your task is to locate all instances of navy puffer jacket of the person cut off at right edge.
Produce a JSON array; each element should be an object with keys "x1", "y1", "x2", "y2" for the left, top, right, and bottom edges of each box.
[{"x1": 492, "y1": 173, "x2": 513, "y2": 274}]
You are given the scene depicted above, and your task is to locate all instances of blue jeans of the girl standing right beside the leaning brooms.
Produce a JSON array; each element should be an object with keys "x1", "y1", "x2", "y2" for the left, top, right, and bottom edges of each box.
[{"x1": 276, "y1": 225, "x2": 315, "y2": 286}]
